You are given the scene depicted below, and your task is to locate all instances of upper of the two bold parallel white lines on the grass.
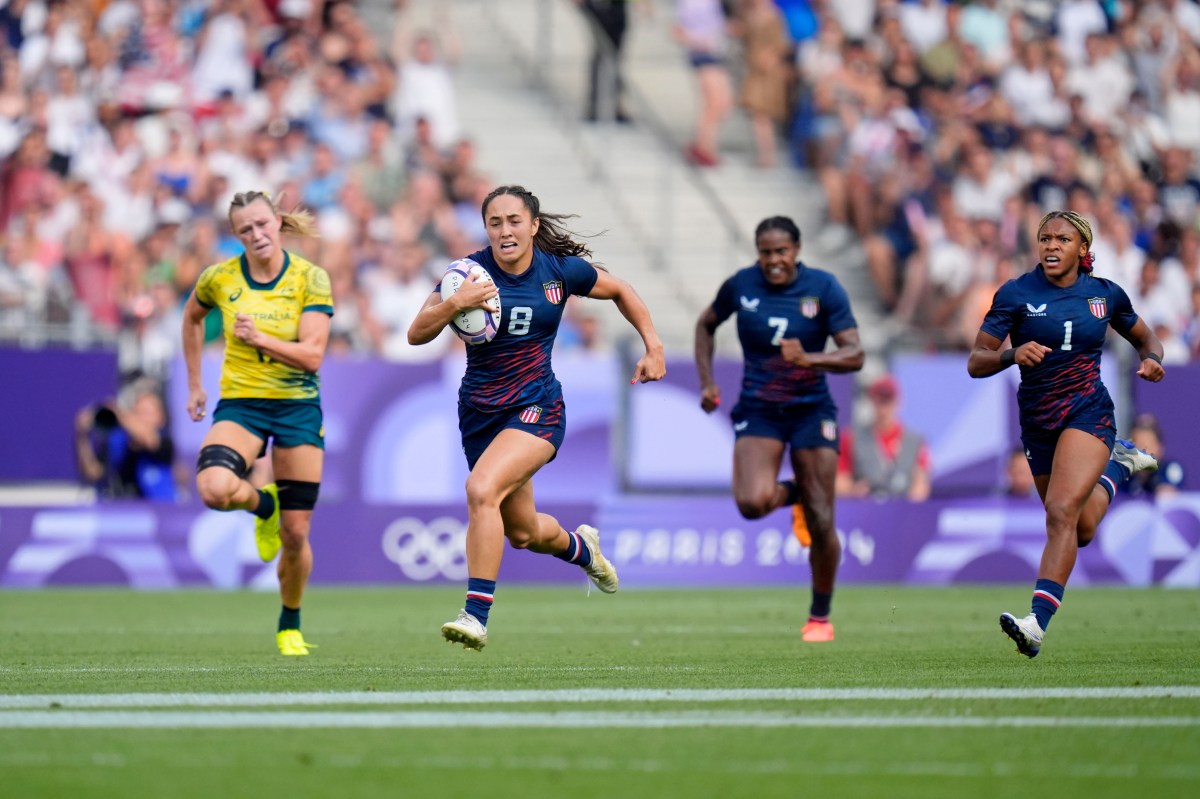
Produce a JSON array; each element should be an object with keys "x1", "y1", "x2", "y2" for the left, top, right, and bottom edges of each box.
[{"x1": 0, "y1": 685, "x2": 1200, "y2": 709}]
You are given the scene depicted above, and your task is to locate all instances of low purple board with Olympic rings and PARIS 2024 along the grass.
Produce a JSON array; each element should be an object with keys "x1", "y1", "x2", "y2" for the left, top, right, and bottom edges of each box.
[{"x1": 0, "y1": 493, "x2": 1200, "y2": 590}]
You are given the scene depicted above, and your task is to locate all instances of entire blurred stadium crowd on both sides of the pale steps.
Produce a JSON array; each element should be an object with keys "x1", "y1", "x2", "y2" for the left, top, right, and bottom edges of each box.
[{"x1": 0, "y1": 0, "x2": 1200, "y2": 378}]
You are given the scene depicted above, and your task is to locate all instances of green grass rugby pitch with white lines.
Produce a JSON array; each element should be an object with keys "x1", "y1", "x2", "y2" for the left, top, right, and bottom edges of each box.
[{"x1": 0, "y1": 585, "x2": 1200, "y2": 799}]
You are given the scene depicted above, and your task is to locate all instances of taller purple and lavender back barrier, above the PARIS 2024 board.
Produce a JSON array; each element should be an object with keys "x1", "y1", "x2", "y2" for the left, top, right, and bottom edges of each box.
[{"x1": 7, "y1": 349, "x2": 1200, "y2": 494}]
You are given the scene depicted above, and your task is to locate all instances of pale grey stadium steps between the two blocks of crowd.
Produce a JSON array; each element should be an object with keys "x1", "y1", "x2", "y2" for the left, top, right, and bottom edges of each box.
[{"x1": 367, "y1": 0, "x2": 877, "y2": 354}]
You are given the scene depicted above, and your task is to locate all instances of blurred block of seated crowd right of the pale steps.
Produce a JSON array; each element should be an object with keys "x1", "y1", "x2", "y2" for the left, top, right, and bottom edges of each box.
[{"x1": 780, "y1": 0, "x2": 1200, "y2": 355}]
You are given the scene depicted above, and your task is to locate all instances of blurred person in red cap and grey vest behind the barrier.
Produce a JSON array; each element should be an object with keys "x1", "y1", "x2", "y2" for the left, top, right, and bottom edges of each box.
[{"x1": 836, "y1": 374, "x2": 930, "y2": 501}]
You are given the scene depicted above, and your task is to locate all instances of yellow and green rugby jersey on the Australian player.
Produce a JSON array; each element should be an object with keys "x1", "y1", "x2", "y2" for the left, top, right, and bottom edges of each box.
[{"x1": 196, "y1": 252, "x2": 334, "y2": 400}]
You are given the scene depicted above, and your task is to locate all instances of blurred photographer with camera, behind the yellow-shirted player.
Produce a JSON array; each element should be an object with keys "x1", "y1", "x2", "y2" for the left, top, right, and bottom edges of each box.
[{"x1": 76, "y1": 379, "x2": 176, "y2": 501}]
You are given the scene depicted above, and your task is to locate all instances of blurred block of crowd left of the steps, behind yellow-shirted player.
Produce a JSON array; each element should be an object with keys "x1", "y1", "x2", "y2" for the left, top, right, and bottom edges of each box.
[{"x1": 0, "y1": 0, "x2": 511, "y2": 378}]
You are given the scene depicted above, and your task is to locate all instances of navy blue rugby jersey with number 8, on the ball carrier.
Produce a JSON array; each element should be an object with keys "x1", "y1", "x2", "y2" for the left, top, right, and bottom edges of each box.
[{"x1": 458, "y1": 247, "x2": 599, "y2": 410}]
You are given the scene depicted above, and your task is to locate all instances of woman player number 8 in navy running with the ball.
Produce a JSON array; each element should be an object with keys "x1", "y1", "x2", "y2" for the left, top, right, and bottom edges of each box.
[{"x1": 408, "y1": 186, "x2": 666, "y2": 649}]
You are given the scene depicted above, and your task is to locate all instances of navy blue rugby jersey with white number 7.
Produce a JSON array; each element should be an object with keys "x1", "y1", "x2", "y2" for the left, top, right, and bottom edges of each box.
[{"x1": 713, "y1": 264, "x2": 858, "y2": 405}]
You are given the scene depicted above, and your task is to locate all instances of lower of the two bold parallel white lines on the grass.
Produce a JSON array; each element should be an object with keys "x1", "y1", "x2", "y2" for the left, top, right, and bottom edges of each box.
[{"x1": 0, "y1": 710, "x2": 1200, "y2": 729}]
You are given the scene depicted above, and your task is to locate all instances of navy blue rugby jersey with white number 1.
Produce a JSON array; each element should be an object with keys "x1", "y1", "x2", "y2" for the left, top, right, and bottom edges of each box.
[{"x1": 980, "y1": 264, "x2": 1138, "y2": 429}]
